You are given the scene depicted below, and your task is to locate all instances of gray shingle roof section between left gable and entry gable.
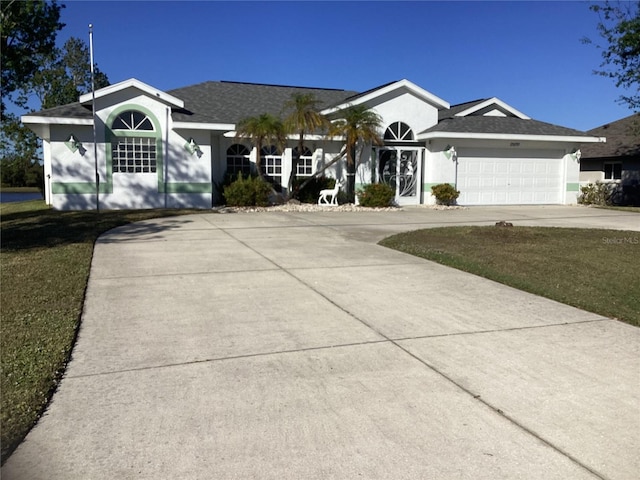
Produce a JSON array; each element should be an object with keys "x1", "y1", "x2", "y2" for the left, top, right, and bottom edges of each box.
[{"x1": 167, "y1": 82, "x2": 357, "y2": 123}]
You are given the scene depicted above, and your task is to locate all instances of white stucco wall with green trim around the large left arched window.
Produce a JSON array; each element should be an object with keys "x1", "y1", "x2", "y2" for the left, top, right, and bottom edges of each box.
[{"x1": 45, "y1": 89, "x2": 212, "y2": 210}]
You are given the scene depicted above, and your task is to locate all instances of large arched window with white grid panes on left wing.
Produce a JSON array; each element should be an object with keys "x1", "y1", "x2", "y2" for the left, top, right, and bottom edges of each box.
[{"x1": 111, "y1": 110, "x2": 157, "y2": 173}]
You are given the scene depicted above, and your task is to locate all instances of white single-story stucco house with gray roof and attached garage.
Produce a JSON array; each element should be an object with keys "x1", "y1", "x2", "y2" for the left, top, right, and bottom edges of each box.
[{"x1": 22, "y1": 79, "x2": 605, "y2": 210}]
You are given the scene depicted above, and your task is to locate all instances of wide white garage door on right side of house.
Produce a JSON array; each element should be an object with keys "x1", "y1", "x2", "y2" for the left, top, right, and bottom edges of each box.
[{"x1": 458, "y1": 149, "x2": 564, "y2": 205}]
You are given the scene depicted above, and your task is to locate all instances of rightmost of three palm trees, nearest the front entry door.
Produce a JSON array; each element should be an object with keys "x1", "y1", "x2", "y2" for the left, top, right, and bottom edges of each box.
[{"x1": 329, "y1": 105, "x2": 384, "y2": 200}]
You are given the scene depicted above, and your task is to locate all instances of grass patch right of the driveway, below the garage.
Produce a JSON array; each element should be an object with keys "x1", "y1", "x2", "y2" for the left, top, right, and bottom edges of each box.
[{"x1": 380, "y1": 226, "x2": 640, "y2": 326}]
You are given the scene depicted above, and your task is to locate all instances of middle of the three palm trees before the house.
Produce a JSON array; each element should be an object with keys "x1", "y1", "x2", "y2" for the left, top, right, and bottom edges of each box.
[{"x1": 284, "y1": 93, "x2": 329, "y2": 196}]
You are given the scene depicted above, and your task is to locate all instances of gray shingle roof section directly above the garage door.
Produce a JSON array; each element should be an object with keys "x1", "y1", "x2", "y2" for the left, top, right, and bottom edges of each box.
[{"x1": 421, "y1": 116, "x2": 589, "y2": 137}]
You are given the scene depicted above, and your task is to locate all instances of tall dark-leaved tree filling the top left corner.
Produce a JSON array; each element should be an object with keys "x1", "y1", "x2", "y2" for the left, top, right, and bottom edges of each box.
[{"x1": 0, "y1": 0, "x2": 64, "y2": 113}]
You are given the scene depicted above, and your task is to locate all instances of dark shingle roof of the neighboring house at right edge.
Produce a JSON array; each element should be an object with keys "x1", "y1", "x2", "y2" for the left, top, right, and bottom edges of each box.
[{"x1": 580, "y1": 113, "x2": 640, "y2": 158}]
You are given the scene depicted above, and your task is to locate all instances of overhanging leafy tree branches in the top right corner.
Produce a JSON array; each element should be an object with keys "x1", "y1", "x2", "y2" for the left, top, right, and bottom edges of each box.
[{"x1": 583, "y1": 1, "x2": 640, "y2": 110}]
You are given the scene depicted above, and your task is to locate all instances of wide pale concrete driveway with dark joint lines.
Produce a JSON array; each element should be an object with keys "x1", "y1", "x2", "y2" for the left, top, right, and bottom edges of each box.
[{"x1": 2, "y1": 207, "x2": 640, "y2": 480}]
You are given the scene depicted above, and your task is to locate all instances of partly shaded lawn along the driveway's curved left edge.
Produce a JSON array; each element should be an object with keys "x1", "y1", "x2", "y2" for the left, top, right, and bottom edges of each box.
[{"x1": 0, "y1": 200, "x2": 197, "y2": 463}]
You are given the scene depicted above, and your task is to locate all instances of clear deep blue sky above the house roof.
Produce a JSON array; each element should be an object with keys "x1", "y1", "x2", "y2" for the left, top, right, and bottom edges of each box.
[{"x1": 52, "y1": 1, "x2": 632, "y2": 130}]
